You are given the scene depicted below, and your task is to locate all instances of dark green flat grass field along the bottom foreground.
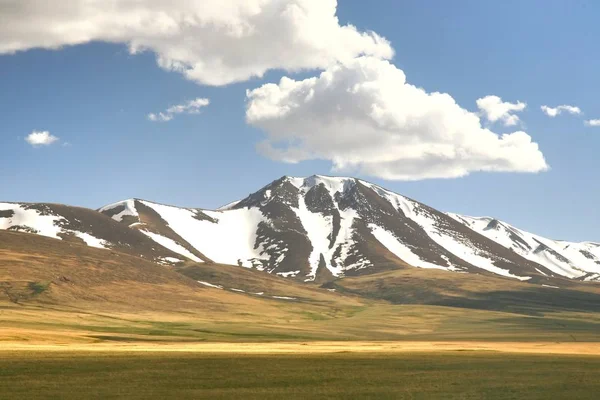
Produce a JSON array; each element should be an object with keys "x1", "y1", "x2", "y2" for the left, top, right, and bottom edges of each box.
[{"x1": 0, "y1": 351, "x2": 600, "y2": 399}]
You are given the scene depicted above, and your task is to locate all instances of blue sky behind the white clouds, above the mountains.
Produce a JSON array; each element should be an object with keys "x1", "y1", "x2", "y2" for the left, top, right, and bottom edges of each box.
[{"x1": 0, "y1": 0, "x2": 600, "y2": 241}]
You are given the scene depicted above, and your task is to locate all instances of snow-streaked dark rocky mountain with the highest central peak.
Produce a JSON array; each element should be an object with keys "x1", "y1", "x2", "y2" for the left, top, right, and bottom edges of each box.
[{"x1": 94, "y1": 175, "x2": 600, "y2": 285}]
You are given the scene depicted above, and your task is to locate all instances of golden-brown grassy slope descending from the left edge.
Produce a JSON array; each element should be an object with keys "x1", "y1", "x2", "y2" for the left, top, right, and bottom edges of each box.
[{"x1": 0, "y1": 231, "x2": 359, "y2": 312}]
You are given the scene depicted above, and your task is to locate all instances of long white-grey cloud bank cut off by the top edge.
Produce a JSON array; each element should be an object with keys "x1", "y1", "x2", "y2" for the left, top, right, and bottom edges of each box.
[{"x1": 0, "y1": 0, "x2": 393, "y2": 85}]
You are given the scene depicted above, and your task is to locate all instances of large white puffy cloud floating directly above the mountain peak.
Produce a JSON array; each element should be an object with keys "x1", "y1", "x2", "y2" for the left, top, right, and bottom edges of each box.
[{"x1": 246, "y1": 57, "x2": 548, "y2": 180}]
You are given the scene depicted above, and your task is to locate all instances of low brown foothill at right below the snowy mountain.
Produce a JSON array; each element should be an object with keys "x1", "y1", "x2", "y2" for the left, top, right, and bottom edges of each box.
[{"x1": 328, "y1": 268, "x2": 600, "y2": 315}]
